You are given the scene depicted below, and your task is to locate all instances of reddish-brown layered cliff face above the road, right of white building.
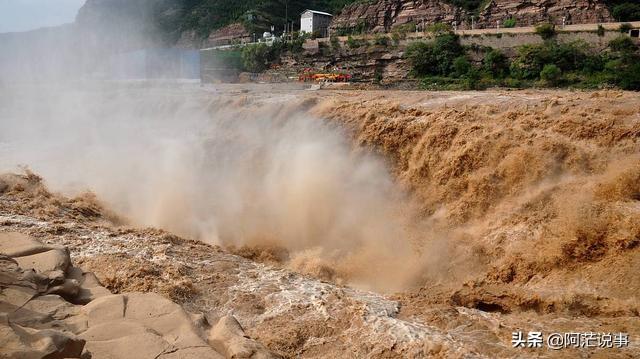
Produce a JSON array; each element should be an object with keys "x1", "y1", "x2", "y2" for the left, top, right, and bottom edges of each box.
[{"x1": 332, "y1": 0, "x2": 613, "y2": 32}]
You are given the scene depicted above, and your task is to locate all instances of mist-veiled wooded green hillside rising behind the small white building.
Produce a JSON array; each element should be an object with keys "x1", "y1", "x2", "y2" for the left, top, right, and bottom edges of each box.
[{"x1": 76, "y1": 0, "x2": 364, "y2": 47}]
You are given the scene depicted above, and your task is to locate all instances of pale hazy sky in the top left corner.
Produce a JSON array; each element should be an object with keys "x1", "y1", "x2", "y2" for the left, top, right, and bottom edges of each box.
[{"x1": 0, "y1": 0, "x2": 85, "y2": 33}]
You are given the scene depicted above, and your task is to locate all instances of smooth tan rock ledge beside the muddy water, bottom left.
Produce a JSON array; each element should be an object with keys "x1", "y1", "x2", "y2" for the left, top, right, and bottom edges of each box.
[{"x1": 0, "y1": 233, "x2": 279, "y2": 359}]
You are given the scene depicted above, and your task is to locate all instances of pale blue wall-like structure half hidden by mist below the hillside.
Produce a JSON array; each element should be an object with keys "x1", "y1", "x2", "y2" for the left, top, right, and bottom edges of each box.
[{"x1": 106, "y1": 48, "x2": 200, "y2": 80}]
